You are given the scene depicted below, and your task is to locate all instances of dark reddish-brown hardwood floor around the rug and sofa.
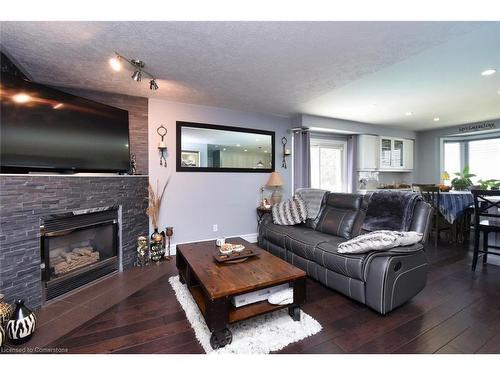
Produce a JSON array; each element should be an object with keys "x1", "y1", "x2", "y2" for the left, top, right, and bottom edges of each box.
[{"x1": 52, "y1": 241, "x2": 500, "y2": 353}]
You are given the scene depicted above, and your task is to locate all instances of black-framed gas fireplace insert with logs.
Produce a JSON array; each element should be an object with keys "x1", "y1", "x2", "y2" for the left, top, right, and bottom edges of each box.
[{"x1": 40, "y1": 207, "x2": 119, "y2": 302}]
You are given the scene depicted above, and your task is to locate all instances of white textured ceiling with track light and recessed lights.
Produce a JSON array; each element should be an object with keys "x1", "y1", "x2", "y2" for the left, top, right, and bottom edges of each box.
[{"x1": 1, "y1": 22, "x2": 500, "y2": 129}]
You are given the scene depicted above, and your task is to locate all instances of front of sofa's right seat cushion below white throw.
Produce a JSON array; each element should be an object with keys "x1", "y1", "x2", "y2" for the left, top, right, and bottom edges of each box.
[{"x1": 313, "y1": 241, "x2": 369, "y2": 280}]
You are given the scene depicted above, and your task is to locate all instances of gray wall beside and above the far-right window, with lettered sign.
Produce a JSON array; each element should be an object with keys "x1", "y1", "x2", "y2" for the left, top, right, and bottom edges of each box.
[{"x1": 415, "y1": 119, "x2": 500, "y2": 183}]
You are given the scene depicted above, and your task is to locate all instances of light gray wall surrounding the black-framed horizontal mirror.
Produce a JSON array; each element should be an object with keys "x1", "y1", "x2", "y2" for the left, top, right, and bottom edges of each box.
[{"x1": 149, "y1": 99, "x2": 292, "y2": 243}]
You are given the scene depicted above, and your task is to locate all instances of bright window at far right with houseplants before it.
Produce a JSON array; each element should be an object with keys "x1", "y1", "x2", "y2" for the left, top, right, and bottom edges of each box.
[{"x1": 443, "y1": 138, "x2": 500, "y2": 183}]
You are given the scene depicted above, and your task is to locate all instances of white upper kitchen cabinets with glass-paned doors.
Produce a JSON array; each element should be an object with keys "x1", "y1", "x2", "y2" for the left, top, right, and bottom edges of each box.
[{"x1": 357, "y1": 134, "x2": 414, "y2": 172}]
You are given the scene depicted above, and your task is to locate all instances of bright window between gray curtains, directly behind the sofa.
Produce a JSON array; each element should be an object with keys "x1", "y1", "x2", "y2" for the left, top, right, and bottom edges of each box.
[{"x1": 311, "y1": 139, "x2": 347, "y2": 192}]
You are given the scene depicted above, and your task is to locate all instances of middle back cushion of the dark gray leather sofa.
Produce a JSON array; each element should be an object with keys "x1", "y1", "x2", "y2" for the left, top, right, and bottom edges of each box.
[{"x1": 316, "y1": 193, "x2": 364, "y2": 239}]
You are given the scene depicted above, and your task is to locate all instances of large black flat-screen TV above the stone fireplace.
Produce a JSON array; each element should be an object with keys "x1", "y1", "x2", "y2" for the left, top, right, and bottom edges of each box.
[{"x1": 0, "y1": 74, "x2": 130, "y2": 173}]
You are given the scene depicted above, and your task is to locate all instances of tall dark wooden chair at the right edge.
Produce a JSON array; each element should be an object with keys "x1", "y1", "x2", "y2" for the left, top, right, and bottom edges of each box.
[{"x1": 471, "y1": 190, "x2": 500, "y2": 271}]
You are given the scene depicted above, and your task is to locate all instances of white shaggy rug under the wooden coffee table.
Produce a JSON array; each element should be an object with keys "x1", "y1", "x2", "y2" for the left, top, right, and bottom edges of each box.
[{"x1": 168, "y1": 276, "x2": 323, "y2": 354}]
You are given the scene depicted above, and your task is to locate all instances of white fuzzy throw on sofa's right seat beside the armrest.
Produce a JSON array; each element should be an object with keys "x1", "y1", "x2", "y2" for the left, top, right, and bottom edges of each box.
[{"x1": 338, "y1": 230, "x2": 422, "y2": 254}]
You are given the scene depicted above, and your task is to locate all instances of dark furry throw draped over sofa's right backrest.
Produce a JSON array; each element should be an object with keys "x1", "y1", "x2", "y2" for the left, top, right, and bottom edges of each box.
[{"x1": 363, "y1": 190, "x2": 422, "y2": 232}]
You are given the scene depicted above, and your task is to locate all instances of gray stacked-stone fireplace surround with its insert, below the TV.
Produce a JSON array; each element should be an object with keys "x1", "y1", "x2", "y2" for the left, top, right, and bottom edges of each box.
[{"x1": 0, "y1": 174, "x2": 149, "y2": 308}]
